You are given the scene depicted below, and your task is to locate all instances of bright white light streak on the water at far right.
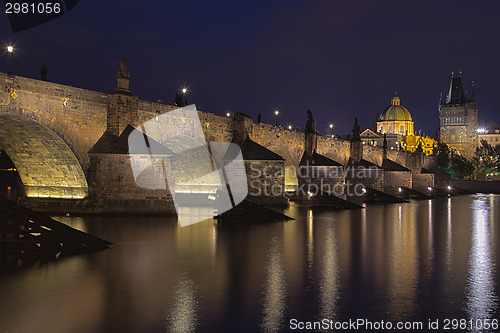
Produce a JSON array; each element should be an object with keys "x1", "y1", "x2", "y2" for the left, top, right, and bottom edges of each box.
[{"x1": 467, "y1": 198, "x2": 497, "y2": 320}]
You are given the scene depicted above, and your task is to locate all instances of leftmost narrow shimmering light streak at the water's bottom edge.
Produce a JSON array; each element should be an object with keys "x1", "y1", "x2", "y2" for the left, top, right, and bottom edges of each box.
[{"x1": 167, "y1": 277, "x2": 198, "y2": 333}]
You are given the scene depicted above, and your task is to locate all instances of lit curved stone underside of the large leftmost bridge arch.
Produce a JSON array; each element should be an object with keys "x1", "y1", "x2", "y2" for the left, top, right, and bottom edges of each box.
[{"x1": 0, "y1": 113, "x2": 88, "y2": 198}]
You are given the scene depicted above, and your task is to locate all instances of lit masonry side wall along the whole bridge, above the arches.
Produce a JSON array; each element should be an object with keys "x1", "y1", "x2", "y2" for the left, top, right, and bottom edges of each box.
[{"x1": 0, "y1": 73, "x2": 434, "y2": 176}]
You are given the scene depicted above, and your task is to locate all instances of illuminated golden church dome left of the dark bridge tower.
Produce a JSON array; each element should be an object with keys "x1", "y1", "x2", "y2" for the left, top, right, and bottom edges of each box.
[{"x1": 377, "y1": 94, "x2": 413, "y2": 135}]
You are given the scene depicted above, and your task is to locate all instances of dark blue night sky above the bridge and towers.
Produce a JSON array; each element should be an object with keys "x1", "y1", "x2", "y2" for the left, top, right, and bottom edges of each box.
[{"x1": 0, "y1": 0, "x2": 500, "y2": 136}]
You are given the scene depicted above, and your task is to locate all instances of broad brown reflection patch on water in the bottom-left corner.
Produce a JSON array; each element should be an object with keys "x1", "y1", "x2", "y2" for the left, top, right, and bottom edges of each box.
[{"x1": 0, "y1": 257, "x2": 106, "y2": 333}]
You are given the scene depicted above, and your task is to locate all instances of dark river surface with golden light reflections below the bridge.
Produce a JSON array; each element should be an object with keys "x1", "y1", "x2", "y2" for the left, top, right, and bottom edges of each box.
[{"x1": 0, "y1": 195, "x2": 500, "y2": 333}]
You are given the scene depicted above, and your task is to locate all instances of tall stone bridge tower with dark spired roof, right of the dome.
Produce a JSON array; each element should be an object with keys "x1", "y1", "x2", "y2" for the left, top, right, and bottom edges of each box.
[{"x1": 439, "y1": 74, "x2": 479, "y2": 158}]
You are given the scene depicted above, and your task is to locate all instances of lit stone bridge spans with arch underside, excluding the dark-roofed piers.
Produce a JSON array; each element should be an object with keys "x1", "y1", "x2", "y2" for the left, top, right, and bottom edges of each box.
[{"x1": 0, "y1": 69, "x2": 432, "y2": 204}]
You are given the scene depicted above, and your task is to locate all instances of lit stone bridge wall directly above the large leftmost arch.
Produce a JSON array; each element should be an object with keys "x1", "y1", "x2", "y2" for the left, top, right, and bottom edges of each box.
[{"x1": 0, "y1": 73, "x2": 107, "y2": 172}]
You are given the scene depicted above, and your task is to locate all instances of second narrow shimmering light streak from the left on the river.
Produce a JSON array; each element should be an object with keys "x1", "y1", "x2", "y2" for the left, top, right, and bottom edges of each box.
[{"x1": 262, "y1": 237, "x2": 286, "y2": 332}]
